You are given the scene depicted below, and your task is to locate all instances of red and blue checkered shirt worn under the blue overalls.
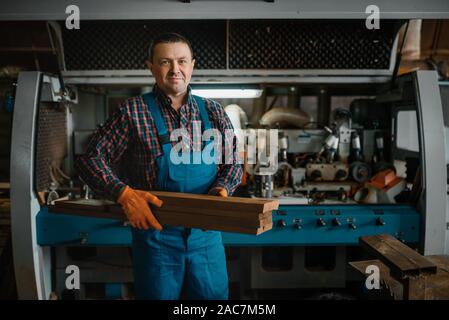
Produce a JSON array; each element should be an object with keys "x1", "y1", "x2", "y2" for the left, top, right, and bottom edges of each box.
[{"x1": 75, "y1": 85, "x2": 242, "y2": 199}]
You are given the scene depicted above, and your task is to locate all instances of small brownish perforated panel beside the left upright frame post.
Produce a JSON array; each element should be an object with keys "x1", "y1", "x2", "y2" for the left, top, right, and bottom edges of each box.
[{"x1": 35, "y1": 103, "x2": 67, "y2": 191}]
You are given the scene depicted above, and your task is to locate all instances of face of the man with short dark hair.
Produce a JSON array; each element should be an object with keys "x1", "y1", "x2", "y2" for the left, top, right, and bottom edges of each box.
[{"x1": 147, "y1": 42, "x2": 195, "y2": 96}]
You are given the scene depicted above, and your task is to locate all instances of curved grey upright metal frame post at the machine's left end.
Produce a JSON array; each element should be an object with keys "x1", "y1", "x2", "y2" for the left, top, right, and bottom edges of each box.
[{"x1": 11, "y1": 72, "x2": 51, "y2": 299}]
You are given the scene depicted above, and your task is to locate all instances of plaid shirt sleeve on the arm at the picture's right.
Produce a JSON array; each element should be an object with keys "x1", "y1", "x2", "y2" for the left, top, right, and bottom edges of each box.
[{"x1": 205, "y1": 99, "x2": 243, "y2": 195}]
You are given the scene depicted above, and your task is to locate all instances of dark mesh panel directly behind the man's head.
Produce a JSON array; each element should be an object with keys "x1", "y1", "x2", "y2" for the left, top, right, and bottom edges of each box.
[{"x1": 61, "y1": 20, "x2": 226, "y2": 70}]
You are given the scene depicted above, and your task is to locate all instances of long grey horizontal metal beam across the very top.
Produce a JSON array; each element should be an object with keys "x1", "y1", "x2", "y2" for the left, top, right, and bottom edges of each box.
[{"x1": 0, "y1": 0, "x2": 449, "y2": 19}]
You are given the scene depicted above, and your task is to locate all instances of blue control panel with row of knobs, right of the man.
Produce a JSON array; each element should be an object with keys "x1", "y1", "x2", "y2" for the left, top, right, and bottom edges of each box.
[{"x1": 222, "y1": 204, "x2": 420, "y2": 246}]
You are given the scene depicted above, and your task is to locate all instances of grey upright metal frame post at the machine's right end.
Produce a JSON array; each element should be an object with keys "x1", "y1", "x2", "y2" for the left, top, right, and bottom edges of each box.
[{"x1": 413, "y1": 71, "x2": 447, "y2": 255}]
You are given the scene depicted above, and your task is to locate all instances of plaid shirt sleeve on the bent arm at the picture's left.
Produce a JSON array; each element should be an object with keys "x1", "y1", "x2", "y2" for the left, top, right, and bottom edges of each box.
[{"x1": 75, "y1": 102, "x2": 131, "y2": 200}]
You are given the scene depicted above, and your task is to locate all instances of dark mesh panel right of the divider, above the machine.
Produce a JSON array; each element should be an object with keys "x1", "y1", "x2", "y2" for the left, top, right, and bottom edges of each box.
[{"x1": 229, "y1": 20, "x2": 399, "y2": 69}]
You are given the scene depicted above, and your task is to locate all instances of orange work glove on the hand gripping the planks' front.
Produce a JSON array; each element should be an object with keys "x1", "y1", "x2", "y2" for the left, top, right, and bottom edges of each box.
[{"x1": 117, "y1": 186, "x2": 162, "y2": 230}]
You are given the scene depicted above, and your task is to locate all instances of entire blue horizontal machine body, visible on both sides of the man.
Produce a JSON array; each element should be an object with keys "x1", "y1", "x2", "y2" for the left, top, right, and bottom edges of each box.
[{"x1": 36, "y1": 205, "x2": 421, "y2": 246}]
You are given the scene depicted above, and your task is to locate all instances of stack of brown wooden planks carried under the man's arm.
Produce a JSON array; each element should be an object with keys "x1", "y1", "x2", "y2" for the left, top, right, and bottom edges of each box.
[{"x1": 49, "y1": 191, "x2": 279, "y2": 235}]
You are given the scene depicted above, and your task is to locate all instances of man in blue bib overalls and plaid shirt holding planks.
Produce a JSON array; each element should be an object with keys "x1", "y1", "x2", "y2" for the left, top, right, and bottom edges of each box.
[{"x1": 76, "y1": 33, "x2": 242, "y2": 299}]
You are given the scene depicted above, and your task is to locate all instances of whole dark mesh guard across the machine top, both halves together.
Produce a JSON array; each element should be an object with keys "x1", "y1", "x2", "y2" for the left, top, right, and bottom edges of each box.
[{"x1": 62, "y1": 20, "x2": 401, "y2": 71}]
